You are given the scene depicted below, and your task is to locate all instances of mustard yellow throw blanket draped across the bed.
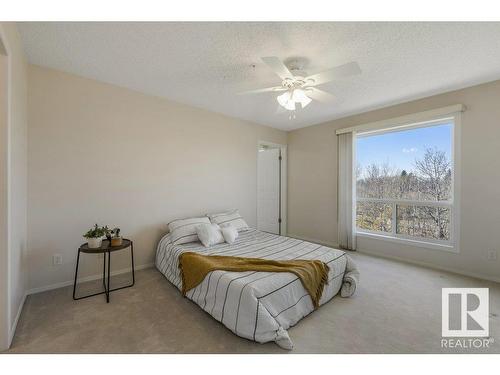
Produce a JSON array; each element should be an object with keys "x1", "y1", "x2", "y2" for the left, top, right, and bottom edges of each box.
[{"x1": 179, "y1": 252, "x2": 329, "y2": 309}]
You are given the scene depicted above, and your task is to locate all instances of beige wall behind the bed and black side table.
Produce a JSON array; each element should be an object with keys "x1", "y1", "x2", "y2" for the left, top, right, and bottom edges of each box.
[{"x1": 28, "y1": 65, "x2": 286, "y2": 288}]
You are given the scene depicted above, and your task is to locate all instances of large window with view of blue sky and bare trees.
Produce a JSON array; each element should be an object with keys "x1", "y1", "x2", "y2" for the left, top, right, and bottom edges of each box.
[{"x1": 354, "y1": 117, "x2": 457, "y2": 253}]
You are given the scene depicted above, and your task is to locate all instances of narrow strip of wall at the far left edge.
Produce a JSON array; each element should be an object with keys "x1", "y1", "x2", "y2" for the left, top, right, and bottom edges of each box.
[{"x1": 0, "y1": 22, "x2": 27, "y2": 350}]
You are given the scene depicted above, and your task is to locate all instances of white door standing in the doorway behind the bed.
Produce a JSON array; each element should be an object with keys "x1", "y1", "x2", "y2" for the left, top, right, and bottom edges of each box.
[{"x1": 257, "y1": 148, "x2": 280, "y2": 234}]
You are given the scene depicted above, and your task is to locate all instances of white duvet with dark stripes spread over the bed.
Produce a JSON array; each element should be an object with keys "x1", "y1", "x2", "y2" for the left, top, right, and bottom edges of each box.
[{"x1": 156, "y1": 229, "x2": 353, "y2": 349}]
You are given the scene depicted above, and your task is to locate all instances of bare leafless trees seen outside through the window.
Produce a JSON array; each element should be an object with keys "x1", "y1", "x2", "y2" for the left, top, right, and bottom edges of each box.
[{"x1": 356, "y1": 142, "x2": 452, "y2": 241}]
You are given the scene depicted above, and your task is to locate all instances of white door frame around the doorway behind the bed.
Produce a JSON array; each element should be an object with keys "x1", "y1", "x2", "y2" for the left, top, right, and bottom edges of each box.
[{"x1": 255, "y1": 141, "x2": 288, "y2": 236}]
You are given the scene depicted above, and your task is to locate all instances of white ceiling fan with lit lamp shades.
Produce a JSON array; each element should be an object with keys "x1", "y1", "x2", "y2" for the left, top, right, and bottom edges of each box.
[{"x1": 240, "y1": 56, "x2": 361, "y2": 111}]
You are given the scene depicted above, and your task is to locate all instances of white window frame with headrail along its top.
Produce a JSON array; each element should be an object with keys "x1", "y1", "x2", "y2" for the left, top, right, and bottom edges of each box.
[{"x1": 337, "y1": 104, "x2": 465, "y2": 253}]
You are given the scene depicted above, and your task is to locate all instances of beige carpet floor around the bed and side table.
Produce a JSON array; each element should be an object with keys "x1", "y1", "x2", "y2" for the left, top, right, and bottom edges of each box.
[{"x1": 4, "y1": 253, "x2": 500, "y2": 353}]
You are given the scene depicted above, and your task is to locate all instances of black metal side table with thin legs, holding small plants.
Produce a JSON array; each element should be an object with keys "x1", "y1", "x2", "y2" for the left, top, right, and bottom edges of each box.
[{"x1": 73, "y1": 238, "x2": 135, "y2": 303}]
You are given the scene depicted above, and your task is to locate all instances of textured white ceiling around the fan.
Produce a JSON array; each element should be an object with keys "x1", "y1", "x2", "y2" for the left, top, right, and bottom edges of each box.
[{"x1": 19, "y1": 22, "x2": 500, "y2": 130}]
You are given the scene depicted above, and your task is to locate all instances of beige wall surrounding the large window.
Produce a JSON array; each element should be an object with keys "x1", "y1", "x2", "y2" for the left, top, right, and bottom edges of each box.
[{"x1": 288, "y1": 81, "x2": 500, "y2": 281}]
